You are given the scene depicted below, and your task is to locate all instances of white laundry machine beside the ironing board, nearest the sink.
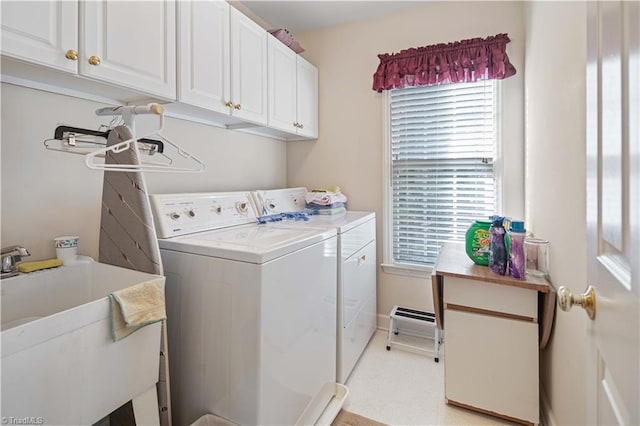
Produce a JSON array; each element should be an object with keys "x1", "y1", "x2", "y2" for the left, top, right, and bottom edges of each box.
[{"x1": 150, "y1": 192, "x2": 346, "y2": 426}]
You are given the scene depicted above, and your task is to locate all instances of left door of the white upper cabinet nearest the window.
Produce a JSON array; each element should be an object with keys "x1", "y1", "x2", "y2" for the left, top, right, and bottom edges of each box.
[{"x1": 267, "y1": 35, "x2": 297, "y2": 133}]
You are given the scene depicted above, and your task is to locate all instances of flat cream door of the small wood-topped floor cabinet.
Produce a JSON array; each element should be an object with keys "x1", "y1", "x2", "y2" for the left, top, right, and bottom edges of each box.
[{"x1": 444, "y1": 308, "x2": 539, "y2": 424}]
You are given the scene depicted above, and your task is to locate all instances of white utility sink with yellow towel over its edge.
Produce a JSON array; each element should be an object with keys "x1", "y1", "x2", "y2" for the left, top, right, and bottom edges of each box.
[{"x1": 0, "y1": 261, "x2": 165, "y2": 425}]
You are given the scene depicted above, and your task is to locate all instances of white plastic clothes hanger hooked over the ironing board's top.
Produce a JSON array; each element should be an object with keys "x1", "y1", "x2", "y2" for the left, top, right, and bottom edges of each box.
[{"x1": 85, "y1": 103, "x2": 204, "y2": 173}]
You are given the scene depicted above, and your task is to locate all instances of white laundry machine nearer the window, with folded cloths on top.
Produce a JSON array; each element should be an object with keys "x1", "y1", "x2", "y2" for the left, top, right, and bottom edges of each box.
[{"x1": 252, "y1": 187, "x2": 377, "y2": 383}]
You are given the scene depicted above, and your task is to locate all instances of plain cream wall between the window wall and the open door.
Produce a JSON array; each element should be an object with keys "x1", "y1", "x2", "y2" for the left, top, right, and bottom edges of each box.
[{"x1": 525, "y1": 2, "x2": 588, "y2": 425}]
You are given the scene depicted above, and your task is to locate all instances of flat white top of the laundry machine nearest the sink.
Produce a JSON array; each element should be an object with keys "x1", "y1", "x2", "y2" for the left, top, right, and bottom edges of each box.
[{"x1": 158, "y1": 224, "x2": 336, "y2": 264}]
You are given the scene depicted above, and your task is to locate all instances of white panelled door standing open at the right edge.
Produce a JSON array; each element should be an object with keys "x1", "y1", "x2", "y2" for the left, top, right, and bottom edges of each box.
[{"x1": 587, "y1": 1, "x2": 640, "y2": 425}]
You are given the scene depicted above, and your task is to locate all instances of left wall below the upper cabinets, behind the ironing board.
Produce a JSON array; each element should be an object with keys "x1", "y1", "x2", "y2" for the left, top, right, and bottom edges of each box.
[{"x1": 0, "y1": 83, "x2": 286, "y2": 260}]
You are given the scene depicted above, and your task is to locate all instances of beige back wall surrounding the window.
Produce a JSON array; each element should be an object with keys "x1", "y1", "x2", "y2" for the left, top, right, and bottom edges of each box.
[{"x1": 287, "y1": 2, "x2": 524, "y2": 317}]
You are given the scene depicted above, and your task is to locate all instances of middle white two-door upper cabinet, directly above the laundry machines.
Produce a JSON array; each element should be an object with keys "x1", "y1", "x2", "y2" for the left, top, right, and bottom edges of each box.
[{"x1": 174, "y1": 0, "x2": 267, "y2": 125}]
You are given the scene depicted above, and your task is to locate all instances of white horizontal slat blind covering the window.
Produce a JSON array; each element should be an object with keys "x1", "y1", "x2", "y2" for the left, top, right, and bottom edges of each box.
[{"x1": 389, "y1": 80, "x2": 497, "y2": 266}]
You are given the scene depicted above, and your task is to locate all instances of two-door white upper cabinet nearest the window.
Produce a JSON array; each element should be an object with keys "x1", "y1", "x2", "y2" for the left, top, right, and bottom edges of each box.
[{"x1": 268, "y1": 36, "x2": 318, "y2": 138}]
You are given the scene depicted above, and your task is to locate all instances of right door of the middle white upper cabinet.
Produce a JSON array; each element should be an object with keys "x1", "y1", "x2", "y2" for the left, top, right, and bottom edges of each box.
[{"x1": 231, "y1": 7, "x2": 267, "y2": 125}]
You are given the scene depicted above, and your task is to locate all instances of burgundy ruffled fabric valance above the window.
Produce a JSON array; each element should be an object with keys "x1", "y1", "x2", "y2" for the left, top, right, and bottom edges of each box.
[{"x1": 373, "y1": 34, "x2": 516, "y2": 92}]
